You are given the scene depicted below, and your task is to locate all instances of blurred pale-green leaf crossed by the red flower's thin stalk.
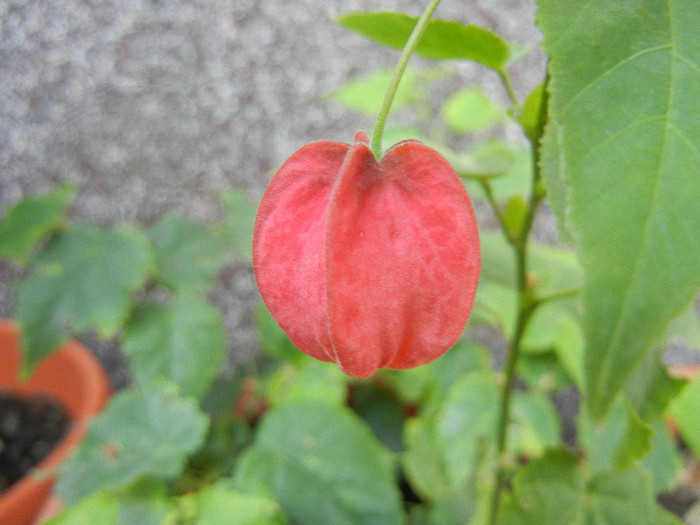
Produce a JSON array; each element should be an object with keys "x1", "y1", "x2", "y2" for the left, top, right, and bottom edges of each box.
[{"x1": 331, "y1": 69, "x2": 420, "y2": 117}]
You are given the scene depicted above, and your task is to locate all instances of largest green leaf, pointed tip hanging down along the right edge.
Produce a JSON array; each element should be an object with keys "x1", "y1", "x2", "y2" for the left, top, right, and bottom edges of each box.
[{"x1": 538, "y1": 0, "x2": 700, "y2": 419}]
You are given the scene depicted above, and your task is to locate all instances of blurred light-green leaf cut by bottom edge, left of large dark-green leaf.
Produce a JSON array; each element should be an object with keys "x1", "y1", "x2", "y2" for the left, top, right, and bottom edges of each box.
[{"x1": 188, "y1": 485, "x2": 287, "y2": 525}]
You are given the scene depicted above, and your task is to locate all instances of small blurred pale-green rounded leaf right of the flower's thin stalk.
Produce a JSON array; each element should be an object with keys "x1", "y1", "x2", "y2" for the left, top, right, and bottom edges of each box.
[{"x1": 441, "y1": 87, "x2": 505, "y2": 134}]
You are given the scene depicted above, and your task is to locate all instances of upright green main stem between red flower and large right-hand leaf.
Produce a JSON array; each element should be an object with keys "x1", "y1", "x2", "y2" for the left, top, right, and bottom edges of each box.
[{"x1": 488, "y1": 70, "x2": 548, "y2": 525}]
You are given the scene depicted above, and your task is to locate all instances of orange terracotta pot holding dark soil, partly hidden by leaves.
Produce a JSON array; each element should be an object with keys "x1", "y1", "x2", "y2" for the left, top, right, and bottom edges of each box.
[{"x1": 0, "y1": 319, "x2": 109, "y2": 525}]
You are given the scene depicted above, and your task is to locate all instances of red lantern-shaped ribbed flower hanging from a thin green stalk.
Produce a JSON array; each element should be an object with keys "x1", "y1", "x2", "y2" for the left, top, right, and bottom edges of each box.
[{"x1": 253, "y1": 132, "x2": 481, "y2": 377}]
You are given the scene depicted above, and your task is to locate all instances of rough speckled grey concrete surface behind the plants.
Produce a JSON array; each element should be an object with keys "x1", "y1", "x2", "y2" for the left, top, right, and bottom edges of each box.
[{"x1": 0, "y1": 0, "x2": 544, "y2": 378}]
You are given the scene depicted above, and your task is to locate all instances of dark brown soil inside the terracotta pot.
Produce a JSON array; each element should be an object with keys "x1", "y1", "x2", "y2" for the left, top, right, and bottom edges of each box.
[{"x1": 0, "y1": 391, "x2": 71, "y2": 494}]
